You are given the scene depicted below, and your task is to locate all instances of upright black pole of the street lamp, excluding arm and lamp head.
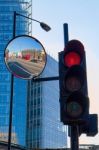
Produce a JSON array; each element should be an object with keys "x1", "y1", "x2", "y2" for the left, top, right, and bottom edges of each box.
[{"x1": 8, "y1": 12, "x2": 16, "y2": 150}]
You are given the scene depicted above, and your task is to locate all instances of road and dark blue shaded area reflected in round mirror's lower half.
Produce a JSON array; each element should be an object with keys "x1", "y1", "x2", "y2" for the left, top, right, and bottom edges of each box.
[{"x1": 7, "y1": 58, "x2": 45, "y2": 78}]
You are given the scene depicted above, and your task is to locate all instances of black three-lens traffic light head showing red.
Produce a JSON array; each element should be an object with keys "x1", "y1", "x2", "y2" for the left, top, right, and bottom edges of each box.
[{"x1": 59, "y1": 40, "x2": 89, "y2": 125}]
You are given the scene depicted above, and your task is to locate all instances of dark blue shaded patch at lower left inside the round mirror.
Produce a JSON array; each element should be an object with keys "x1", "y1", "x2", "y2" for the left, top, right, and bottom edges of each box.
[{"x1": 8, "y1": 62, "x2": 31, "y2": 78}]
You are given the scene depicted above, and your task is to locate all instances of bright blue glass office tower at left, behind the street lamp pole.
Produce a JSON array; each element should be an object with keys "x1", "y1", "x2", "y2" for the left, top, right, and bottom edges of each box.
[{"x1": 0, "y1": 0, "x2": 32, "y2": 145}]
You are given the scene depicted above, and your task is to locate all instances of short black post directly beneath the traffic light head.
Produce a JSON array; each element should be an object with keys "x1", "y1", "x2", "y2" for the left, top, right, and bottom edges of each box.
[{"x1": 71, "y1": 125, "x2": 79, "y2": 150}]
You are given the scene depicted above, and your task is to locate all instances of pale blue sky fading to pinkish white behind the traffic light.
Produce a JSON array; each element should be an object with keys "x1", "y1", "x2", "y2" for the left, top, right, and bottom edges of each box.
[{"x1": 32, "y1": 0, "x2": 99, "y2": 145}]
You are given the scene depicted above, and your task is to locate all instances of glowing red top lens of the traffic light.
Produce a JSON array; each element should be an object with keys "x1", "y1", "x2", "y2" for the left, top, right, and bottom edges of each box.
[{"x1": 64, "y1": 51, "x2": 81, "y2": 67}]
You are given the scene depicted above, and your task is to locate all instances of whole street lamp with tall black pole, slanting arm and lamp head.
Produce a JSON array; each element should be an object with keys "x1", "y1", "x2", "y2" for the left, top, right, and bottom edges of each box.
[{"x1": 8, "y1": 11, "x2": 51, "y2": 150}]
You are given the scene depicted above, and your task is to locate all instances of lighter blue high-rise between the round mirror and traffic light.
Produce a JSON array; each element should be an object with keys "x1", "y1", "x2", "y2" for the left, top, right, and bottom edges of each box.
[{"x1": 26, "y1": 55, "x2": 67, "y2": 149}]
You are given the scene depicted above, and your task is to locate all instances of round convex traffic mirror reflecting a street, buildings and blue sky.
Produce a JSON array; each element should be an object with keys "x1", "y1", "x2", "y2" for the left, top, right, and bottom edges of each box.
[{"x1": 5, "y1": 36, "x2": 46, "y2": 79}]
